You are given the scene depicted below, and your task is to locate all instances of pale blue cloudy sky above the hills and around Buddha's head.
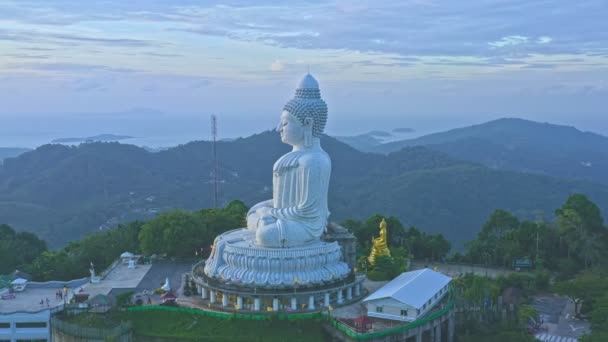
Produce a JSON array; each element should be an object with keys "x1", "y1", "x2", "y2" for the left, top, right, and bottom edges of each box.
[{"x1": 0, "y1": 0, "x2": 608, "y2": 145}]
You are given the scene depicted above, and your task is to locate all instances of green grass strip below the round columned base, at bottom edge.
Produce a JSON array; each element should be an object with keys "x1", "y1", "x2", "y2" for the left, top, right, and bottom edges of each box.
[{"x1": 63, "y1": 310, "x2": 328, "y2": 342}]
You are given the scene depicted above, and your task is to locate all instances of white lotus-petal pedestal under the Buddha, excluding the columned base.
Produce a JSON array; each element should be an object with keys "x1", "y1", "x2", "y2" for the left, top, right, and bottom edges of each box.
[{"x1": 204, "y1": 228, "x2": 351, "y2": 289}]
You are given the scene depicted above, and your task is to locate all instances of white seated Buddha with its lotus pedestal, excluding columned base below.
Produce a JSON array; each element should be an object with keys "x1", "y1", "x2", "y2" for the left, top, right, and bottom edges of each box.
[{"x1": 204, "y1": 75, "x2": 350, "y2": 288}]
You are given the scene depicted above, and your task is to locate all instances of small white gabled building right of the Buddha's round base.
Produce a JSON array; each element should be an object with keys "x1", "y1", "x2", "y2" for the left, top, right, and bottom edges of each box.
[{"x1": 363, "y1": 268, "x2": 452, "y2": 321}]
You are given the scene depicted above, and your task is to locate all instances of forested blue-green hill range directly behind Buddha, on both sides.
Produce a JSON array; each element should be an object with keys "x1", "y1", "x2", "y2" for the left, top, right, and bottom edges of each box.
[{"x1": 0, "y1": 128, "x2": 608, "y2": 247}]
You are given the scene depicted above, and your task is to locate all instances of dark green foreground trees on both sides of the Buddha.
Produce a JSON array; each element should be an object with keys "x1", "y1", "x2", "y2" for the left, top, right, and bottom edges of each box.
[{"x1": 0, "y1": 194, "x2": 608, "y2": 342}]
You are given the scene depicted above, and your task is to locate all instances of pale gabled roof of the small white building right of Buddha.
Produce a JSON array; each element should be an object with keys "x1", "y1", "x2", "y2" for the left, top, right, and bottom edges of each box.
[{"x1": 363, "y1": 268, "x2": 452, "y2": 309}]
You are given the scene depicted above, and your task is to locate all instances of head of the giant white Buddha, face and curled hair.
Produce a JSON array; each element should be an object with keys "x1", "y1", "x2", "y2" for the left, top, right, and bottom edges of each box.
[{"x1": 278, "y1": 74, "x2": 327, "y2": 147}]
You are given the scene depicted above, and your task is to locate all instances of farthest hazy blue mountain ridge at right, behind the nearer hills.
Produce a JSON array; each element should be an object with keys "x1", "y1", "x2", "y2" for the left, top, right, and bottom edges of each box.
[{"x1": 352, "y1": 118, "x2": 608, "y2": 184}]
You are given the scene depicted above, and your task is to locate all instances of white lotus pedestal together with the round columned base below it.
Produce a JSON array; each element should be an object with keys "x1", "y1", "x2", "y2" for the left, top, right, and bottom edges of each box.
[{"x1": 193, "y1": 229, "x2": 364, "y2": 313}]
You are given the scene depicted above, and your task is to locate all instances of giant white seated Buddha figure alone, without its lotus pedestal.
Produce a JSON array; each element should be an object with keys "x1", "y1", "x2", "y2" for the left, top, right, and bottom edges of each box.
[{"x1": 247, "y1": 74, "x2": 331, "y2": 247}]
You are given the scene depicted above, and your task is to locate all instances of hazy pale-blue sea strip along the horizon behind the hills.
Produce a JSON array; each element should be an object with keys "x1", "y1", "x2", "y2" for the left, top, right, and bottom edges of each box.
[{"x1": 0, "y1": 112, "x2": 608, "y2": 148}]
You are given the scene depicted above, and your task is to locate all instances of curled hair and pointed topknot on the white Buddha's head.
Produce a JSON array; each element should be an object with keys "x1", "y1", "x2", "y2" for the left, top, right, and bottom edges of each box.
[{"x1": 283, "y1": 74, "x2": 327, "y2": 137}]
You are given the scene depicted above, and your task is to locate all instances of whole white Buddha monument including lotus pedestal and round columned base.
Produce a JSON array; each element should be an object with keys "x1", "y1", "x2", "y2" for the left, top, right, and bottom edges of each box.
[{"x1": 193, "y1": 74, "x2": 363, "y2": 311}]
